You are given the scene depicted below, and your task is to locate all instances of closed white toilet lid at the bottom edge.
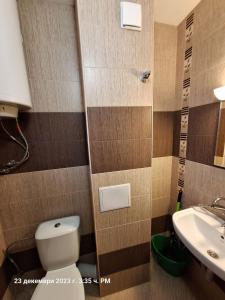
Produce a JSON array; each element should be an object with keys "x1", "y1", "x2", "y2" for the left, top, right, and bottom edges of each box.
[{"x1": 31, "y1": 264, "x2": 85, "y2": 300}]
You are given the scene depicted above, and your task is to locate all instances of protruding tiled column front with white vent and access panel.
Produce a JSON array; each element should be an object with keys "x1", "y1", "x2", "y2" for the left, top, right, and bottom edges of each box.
[{"x1": 77, "y1": 0, "x2": 154, "y2": 295}]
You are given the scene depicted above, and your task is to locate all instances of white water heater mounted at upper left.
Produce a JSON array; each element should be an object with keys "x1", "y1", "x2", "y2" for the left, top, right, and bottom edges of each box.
[{"x1": 0, "y1": 0, "x2": 32, "y2": 118}]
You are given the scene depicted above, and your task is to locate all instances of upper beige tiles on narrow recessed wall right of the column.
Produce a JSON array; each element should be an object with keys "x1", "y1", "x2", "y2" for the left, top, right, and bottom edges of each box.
[{"x1": 154, "y1": 23, "x2": 177, "y2": 111}]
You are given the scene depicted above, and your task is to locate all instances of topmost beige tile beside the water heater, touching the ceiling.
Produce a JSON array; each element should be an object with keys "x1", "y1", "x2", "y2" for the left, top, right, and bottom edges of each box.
[{"x1": 18, "y1": 0, "x2": 77, "y2": 43}]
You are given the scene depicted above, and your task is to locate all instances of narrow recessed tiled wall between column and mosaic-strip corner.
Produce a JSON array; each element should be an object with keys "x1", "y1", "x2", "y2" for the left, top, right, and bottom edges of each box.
[{"x1": 152, "y1": 23, "x2": 180, "y2": 226}]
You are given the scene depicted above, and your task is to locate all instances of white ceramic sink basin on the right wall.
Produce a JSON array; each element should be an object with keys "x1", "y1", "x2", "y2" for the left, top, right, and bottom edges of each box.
[{"x1": 173, "y1": 206, "x2": 225, "y2": 280}]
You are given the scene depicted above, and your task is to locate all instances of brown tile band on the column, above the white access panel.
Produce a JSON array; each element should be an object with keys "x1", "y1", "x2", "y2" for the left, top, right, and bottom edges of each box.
[{"x1": 88, "y1": 107, "x2": 152, "y2": 173}]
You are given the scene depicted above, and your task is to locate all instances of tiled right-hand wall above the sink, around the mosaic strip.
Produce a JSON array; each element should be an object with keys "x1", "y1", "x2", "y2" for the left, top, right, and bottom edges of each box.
[{"x1": 177, "y1": 0, "x2": 225, "y2": 206}]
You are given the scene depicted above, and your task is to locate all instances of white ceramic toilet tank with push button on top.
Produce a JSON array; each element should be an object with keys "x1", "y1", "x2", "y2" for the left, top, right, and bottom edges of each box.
[{"x1": 35, "y1": 216, "x2": 80, "y2": 271}]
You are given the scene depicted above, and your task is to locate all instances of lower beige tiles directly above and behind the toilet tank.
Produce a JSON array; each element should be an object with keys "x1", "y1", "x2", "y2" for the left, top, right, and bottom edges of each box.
[{"x1": 0, "y1": 166, "x2": 94, "y2": 245}]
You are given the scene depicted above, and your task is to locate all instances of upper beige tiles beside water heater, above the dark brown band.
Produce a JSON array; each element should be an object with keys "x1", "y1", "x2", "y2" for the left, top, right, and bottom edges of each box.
[{"x1": 18, "y1": 0, "x2": 84, "y2": 112}]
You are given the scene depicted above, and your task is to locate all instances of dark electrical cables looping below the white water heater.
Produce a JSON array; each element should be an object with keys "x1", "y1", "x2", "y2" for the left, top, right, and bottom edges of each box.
[{"x1": 0, "y1": 119, "x2": 29, "y2": 175}]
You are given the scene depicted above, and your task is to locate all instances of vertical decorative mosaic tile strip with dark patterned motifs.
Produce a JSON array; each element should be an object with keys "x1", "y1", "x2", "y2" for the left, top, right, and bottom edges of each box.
[{"x1": 177, "y1": 13, "x2": 194, "y2": 190}]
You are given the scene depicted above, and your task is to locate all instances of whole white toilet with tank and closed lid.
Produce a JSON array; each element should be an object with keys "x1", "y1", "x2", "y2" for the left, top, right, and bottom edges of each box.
[{"x1": 31, "y1": 216, "x2": 85, "y2": 300}]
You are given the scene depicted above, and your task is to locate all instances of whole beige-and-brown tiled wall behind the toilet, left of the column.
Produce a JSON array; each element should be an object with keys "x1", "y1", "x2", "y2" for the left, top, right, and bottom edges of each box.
[{"x1": 0, "y1": 0, "x2": 94, "y2": 260}]
